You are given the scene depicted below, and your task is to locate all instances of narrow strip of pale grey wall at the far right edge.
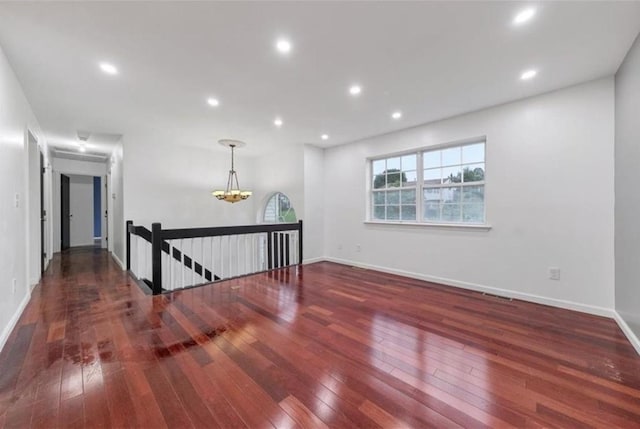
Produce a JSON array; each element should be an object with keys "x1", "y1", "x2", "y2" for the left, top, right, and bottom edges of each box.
[{"x1": 615, "y1": 36, "x2": 640, "y2": 353}]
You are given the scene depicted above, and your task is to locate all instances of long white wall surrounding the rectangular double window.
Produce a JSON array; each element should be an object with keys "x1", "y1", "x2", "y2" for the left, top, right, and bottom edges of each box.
[{"x1": 324, "y1": 78, "x2": 614, "y2": 314}]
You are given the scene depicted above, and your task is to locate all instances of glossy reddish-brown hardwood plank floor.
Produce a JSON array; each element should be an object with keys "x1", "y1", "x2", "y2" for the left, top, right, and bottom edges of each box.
[{"x1": 0, "y1": 249, "x2": 640, "y2": 428}]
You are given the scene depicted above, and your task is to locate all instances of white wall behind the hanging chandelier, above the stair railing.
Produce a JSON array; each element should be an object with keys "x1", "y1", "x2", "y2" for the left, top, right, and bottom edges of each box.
[{"x1": 123, "y1": 130, "x2": 255, "y2": 229}]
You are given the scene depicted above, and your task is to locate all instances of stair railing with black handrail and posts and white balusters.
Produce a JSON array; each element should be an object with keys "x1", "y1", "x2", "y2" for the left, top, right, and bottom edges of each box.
[{"x1": 126, "y1": 221, "x2": 303, "y2": 295}]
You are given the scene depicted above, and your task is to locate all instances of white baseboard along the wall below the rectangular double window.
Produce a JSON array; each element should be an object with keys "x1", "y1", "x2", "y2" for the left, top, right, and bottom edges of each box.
[{"x1": 324, "y1": 257, "x2": 615, "y2": 319}]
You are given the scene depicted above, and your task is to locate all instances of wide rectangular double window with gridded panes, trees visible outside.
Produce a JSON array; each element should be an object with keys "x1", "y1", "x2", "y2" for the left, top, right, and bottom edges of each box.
[{"x1": 371, "y1": 141, "x2": 485, "y2": 224}]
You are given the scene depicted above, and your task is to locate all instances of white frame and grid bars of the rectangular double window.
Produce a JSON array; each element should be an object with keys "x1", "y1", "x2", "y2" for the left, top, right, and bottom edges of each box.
[{"x1": 364, "y1": 136, "x2": 491, "y2": 230}]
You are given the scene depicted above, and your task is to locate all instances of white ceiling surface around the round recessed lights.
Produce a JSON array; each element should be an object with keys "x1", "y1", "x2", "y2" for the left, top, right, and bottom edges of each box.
[{"x1": 0, "y1": 1, "x2": 640, "y2": 155}]
